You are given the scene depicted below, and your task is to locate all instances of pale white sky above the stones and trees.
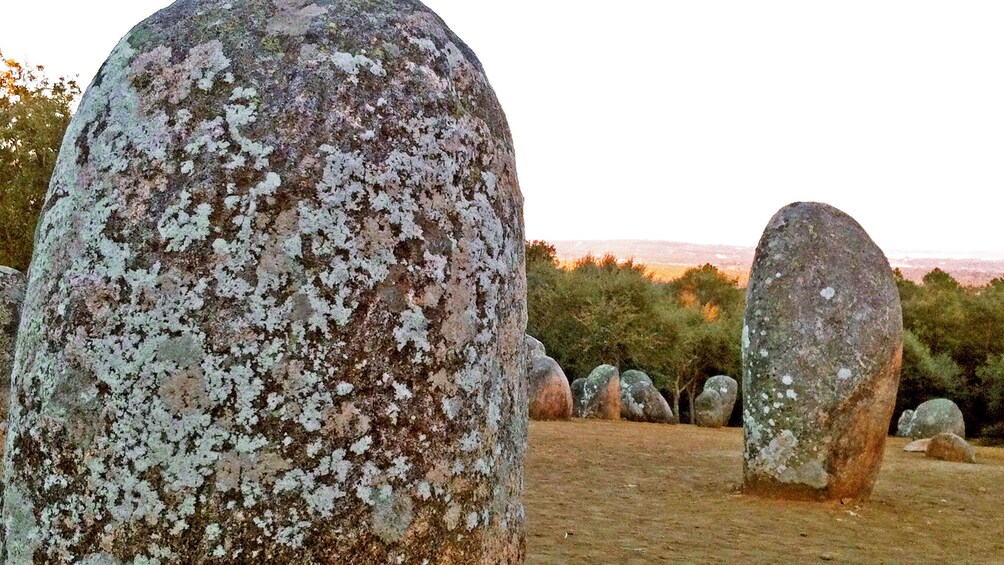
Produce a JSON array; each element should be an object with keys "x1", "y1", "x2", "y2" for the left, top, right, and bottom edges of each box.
[{"x1": 0, "y1": 0, "x2": 1004, "y2": 257}]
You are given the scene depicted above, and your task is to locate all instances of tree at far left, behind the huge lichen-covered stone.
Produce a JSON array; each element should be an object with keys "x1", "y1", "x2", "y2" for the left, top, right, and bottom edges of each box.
[{"x1": 0, "y1": 52, "x2": 80, "y2": 271}]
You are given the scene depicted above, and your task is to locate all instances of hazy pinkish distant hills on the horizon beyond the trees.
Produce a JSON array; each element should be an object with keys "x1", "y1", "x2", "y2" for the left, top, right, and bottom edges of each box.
[{"x1": 548, "y1": 240, "x2": 1004, "y2": 287}]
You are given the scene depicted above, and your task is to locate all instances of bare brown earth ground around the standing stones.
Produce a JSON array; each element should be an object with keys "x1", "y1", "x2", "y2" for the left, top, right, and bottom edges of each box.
[{"x1": 526, "y1": 419, "x2": 1004, "y2": 564}]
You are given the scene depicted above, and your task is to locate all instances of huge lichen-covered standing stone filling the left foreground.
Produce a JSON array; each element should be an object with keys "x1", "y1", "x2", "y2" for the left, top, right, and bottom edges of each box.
[{"x1": 4, "y1": 0, "x2": 527, "y2": 563}]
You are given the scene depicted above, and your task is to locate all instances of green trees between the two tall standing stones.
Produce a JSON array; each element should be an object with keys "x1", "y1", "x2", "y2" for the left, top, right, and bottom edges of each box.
[{"x1": 527, "y1": 242, "x2": 743, "y2": 425}]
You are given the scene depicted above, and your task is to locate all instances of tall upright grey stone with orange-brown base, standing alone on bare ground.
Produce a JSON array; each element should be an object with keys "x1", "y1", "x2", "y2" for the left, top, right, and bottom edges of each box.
[{"x1": 742, "y1": 203, "x2": 903, "y2": 500}]
